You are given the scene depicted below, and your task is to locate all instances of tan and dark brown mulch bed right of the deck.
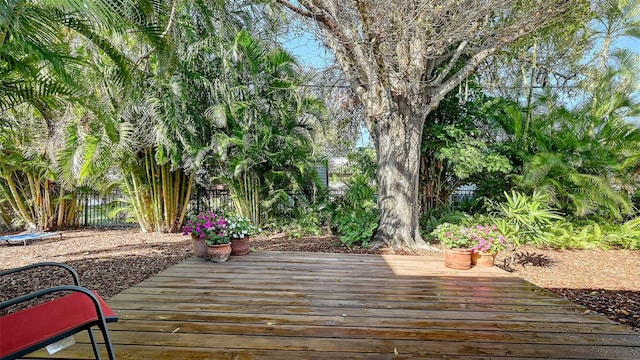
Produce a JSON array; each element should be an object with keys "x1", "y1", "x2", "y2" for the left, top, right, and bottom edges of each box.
[{"x1": 496, "y1": 247, "x2": 640, "y2": 331}]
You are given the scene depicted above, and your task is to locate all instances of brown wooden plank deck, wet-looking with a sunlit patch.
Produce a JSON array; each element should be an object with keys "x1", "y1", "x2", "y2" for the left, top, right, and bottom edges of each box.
[{"x1": 22, "y1": 252, "x2": 640, "y2": 359}]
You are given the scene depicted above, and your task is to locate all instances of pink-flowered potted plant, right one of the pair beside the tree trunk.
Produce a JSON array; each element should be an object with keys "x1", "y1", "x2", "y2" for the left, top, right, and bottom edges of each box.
[{"x1": 469, "y1": 225, "x2": 507, "y2": 266}]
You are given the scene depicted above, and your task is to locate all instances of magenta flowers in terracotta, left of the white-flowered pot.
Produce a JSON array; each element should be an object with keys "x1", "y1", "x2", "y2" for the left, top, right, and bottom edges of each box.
[{"x1": 182, "y1": 211, "x2": 231, "y2": 262}]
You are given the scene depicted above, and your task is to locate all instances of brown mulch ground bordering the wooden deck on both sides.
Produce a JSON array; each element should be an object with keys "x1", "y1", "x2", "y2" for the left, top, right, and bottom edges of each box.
[{"x1": 0, "y1": 229, "x2": 640, "y2": 331}]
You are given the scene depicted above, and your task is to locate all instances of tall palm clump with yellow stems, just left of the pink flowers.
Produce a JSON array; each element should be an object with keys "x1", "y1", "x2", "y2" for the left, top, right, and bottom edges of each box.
[{"x1": 55, "y1": 1, "x2": 258, "y2": 232}]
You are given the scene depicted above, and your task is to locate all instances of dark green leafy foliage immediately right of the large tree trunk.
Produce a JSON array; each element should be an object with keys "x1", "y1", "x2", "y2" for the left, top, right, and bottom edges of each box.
[{"x1": 419, "y1": 84, "x2": 512, "y2": 215}]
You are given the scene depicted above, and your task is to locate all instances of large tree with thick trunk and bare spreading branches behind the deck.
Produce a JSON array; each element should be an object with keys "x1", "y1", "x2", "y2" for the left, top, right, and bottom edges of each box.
[{"x1": 275, "y1": 0, "x2": 589, "y2": 249}]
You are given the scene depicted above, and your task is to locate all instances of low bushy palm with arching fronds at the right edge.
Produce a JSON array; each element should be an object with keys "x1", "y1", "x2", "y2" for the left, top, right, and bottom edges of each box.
[{"x1": 517, "y1": 109, "x2": 640, "y2": 219}]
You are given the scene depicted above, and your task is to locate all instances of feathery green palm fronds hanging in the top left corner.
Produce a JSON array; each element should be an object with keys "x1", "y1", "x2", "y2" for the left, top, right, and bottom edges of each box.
[{"x1": 0, "y1": 0, "x2": 166, "y2": 111}]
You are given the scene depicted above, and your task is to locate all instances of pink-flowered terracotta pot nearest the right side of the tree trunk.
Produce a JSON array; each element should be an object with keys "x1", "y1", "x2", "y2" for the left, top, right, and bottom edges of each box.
[{"x1": 432, "y1": 223, "x2": 471, "y2": 270}]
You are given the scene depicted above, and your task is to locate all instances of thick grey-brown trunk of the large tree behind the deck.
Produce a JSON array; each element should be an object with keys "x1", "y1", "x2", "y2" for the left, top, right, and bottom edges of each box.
[{"x1": 368, "y1": 96, "x2": 427, "y2": 250}]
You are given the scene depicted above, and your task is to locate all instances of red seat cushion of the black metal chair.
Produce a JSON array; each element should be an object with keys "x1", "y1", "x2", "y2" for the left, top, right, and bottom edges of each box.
[{"x1": 0, "y1": 292, "x2": 118, "y2": 356}]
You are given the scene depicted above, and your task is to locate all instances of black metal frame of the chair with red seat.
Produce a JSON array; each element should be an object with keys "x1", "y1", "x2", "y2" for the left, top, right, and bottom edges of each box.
[{"x1": 0, "y1": 262, "x2": 118, "y2": 360}]
